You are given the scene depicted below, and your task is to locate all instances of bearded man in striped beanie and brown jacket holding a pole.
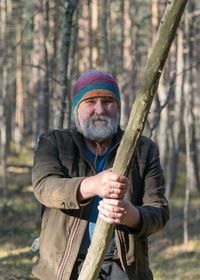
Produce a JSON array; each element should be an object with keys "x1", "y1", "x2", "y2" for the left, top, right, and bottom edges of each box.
[{"x1": 33, "y1": 70, "x2": 169, "y2": 280}]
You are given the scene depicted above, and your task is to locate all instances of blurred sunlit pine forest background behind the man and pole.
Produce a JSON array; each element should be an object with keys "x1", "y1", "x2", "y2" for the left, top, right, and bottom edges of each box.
[{"x1": 0, "y1": 0, "x2": 200, "y2": 280}]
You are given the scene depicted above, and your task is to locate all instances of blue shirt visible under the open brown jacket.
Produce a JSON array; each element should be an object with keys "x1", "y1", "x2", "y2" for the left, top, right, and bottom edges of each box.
[{"x1": 79, "y1": 144, "x2": 115, "y2": 255}]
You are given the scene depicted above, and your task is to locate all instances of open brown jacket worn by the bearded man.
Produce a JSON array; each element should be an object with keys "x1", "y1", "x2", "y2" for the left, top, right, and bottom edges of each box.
[{"x1": 33, "y1": 129, "x2": 169, "y2": 280}]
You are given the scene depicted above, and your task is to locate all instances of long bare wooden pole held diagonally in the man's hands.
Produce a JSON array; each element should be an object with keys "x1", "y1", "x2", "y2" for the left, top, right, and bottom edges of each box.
[{"x1": 78, "y1": 0, "x2": 188, "y2": 280}]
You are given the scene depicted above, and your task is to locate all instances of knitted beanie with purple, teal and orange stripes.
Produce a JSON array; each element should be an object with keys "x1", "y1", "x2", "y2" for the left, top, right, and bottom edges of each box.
[{"x1": 73, "y1": 70, "x2": 121, "y2": 119}]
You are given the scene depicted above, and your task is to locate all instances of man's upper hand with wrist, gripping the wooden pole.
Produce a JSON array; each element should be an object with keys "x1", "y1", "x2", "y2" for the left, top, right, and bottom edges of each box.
[{"x1": 78, "y1": 169, "x2": 130, "y2": 201}]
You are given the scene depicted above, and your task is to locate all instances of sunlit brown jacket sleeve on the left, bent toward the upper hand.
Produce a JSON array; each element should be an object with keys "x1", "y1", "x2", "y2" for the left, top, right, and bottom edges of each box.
[{"x1": 32, "y1": 132, "x2": 84, "y2": 209}]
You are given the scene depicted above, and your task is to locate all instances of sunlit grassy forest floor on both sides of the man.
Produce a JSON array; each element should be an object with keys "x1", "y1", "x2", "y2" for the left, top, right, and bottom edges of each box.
[{"x1": 0, "y1": 149, "x2": 200, "y2": 280}]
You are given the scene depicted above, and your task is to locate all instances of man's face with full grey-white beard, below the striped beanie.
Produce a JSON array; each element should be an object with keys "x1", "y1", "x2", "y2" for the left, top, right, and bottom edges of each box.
[{"x1": 78, "y1": 97, "x2": 120, "y2": 143}]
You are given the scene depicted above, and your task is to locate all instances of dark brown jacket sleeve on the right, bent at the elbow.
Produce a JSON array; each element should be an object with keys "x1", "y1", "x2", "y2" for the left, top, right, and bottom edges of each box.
[{"x1": 135, "y1": 142, "x2": 169, "y2": 237}]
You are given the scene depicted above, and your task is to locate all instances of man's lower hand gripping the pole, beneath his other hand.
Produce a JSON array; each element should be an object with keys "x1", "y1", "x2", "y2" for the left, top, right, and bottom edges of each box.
[{"x1": 98, "y1": 198, "x2": 141, "y2": 229}]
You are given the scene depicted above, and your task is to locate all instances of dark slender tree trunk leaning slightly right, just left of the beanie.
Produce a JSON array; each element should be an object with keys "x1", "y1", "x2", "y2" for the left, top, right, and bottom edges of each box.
[{"x1": 55, "y1": 0, "x2": 78, "y2": 128}]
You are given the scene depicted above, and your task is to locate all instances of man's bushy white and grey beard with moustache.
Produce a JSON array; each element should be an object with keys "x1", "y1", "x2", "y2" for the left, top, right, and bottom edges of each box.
[{"x1": 78, "y1": 111, "x2": 120, "y2": 143}]
